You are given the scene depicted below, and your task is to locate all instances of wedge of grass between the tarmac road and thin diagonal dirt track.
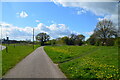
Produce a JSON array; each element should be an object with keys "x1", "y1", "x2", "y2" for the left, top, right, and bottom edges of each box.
[{"x1": 44, "y1": 46, "x2": 97, "y2": 63}]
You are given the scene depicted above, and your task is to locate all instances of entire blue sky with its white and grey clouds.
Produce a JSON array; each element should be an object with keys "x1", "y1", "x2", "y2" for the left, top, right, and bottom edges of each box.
[{"x1": 0, "y1": 0, "x2": 118, "y2": 40}]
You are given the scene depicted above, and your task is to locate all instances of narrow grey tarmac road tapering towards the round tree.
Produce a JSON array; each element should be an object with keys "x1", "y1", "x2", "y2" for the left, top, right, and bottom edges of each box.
[{"x1": 3, "y1": 47, "x2": 66, "y2": 78}]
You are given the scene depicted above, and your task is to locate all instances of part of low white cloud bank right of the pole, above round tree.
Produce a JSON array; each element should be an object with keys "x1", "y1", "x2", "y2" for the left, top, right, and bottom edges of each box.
[{"x1": 35, "y1": 23, "x2": 72, "y2": 38}]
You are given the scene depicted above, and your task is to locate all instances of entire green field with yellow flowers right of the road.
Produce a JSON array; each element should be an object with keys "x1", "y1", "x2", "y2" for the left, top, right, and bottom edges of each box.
[{"x1": 45, "y1": 46, "x2": 119, "y2": 79}]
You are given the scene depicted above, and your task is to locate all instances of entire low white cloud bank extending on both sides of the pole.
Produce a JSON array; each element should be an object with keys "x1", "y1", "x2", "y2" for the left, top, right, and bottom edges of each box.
[{"x1": 0, "y1": 23, "x2": 77, "y2": 40}]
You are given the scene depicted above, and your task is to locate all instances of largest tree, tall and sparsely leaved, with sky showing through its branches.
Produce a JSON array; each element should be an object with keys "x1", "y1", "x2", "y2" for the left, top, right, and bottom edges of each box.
[{"x1": 94, "y1": 19, "x2": 117, "y2": 45}]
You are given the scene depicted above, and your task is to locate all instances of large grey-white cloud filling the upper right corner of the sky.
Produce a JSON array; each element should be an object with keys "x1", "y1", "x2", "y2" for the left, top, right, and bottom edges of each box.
[{"x1": 53, "y1": 0, "x2": 118, "y2": 24}]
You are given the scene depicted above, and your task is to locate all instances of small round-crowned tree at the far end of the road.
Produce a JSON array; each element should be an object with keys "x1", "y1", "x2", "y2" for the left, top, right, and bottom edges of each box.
[{"x1": 36, "y1": 33, "x2": 50, "y2": 46}]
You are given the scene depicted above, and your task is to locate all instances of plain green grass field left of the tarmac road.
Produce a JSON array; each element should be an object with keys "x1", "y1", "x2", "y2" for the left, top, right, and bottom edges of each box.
[{"x1": 2, "y1": 44, "x2": 39, "y2": 75}]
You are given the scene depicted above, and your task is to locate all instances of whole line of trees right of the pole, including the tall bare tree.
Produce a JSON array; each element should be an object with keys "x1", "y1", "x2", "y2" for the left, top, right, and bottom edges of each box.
[{"x1": 36, "y1": 19, "x2": 120, "y2": 46}]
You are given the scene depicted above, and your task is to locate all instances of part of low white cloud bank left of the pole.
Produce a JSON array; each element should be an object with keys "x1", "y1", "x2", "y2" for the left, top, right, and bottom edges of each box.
[{"x1": 0, "y1": 23, "x2": 32, "y2": 39}]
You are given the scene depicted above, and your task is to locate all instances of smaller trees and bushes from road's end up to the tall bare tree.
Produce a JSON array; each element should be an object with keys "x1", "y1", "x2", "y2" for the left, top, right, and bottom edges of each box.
[{"x1": 36, "y1": 33, "x2": 85, "y2": 46}]
